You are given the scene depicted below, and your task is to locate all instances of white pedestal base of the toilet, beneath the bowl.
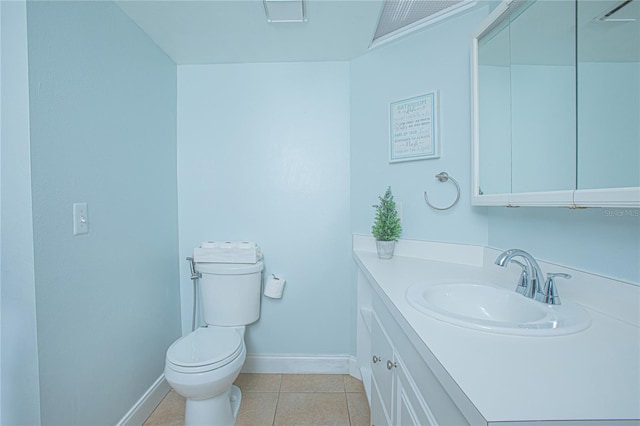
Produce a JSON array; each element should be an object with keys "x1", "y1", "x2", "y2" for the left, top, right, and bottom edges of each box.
[{"x1": 184, "y1": 385, "x2": 242, "y2": 426}]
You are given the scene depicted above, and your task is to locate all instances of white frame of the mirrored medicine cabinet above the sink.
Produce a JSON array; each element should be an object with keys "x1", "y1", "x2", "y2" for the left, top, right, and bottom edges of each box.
[{"x1": 471, "y1": 0, "x2": 640, "y2": 208}]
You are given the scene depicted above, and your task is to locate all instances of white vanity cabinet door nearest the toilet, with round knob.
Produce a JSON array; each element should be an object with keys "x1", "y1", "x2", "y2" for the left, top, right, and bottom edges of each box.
[{"x1": 371, "y1": 314, "x2": 394, "y2": 424}]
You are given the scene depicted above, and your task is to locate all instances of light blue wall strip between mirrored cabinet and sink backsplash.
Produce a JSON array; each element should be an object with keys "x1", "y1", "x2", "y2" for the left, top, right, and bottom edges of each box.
[{"x1": 489, "y1": 207, "x2": 640, "y2": 289}]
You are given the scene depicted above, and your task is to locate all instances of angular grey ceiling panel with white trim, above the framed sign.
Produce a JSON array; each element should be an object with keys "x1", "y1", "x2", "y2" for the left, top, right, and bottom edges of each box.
[{"x1": 370, "y1": 0, "x2": 476, "y2": 47}]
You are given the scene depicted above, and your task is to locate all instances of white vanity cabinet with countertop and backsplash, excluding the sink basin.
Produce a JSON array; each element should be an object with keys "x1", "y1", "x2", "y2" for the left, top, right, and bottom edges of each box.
[{"x1": 354, "y1": 243, "x2": 640, "y2": 426}]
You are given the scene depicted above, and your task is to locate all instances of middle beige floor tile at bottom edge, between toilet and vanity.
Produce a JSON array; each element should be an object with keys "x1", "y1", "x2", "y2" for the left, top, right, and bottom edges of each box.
[{"x1": 274, "y1": 392, "x2": 349, "y2": 426}]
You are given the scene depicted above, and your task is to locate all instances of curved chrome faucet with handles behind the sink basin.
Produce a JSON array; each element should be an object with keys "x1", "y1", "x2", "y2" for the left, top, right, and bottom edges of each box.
[{"x1": 496, "y1": 249, "x2": 571, "y2": 305}]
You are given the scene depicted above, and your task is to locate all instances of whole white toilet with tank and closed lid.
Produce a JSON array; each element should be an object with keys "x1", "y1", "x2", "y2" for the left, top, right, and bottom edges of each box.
[{"x1": 164, "y1": 261, "x2": 264, "y2": 426}]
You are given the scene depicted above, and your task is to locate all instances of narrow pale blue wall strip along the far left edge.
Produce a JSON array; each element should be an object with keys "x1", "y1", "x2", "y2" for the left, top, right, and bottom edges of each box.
[{"x1": 0, "y1": 1, "x2": 40, "y2": 425}]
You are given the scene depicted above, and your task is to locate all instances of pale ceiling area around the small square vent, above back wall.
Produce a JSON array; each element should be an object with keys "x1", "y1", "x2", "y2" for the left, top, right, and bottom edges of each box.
[{"x1": 116, "y1": 0, "x2": 383, "y2": 65}]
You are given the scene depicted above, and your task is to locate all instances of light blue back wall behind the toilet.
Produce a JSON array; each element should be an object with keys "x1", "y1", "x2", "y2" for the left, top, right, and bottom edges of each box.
[{"x1": 178, "y1": 62, "x2": 354, "y2": 355}]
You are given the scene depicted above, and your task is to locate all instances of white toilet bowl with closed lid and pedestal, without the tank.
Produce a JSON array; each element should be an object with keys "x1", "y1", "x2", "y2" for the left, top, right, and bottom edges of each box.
[{"x1": 164, "y1": 326, "x2": 246, "y2": 426}]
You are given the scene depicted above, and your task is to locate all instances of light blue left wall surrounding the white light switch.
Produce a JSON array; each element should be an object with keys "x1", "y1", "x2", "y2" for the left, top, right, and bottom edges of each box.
[{"x1": 27, "y1": 2, "x2": 180, "y2": 425}]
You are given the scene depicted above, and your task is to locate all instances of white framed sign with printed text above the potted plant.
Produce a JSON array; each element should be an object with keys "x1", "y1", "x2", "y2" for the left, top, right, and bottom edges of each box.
[{"x1": 389, "y1": 91, "x2": 440, "y2": 163}]
